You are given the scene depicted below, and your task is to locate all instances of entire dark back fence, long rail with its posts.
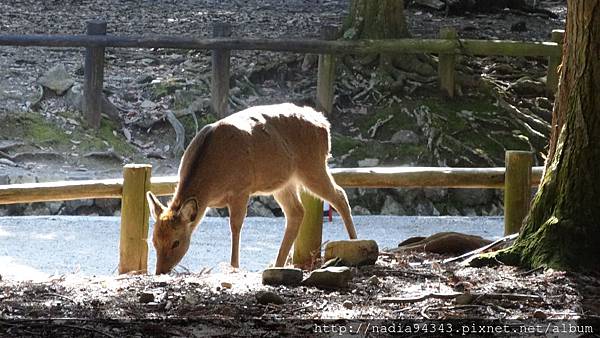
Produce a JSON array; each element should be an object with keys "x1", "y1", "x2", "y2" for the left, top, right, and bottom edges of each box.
[{"x1": 0, "y1": 21, "x2": 564, "y2": 124}]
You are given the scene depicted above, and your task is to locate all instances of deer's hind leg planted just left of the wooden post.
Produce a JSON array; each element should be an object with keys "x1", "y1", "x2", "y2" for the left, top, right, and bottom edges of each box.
[{"x1": 273, "y1": 184, "x2": 304, "y2": 267}]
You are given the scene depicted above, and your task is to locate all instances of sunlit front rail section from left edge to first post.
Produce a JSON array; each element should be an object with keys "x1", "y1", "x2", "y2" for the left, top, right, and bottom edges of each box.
[{"x1": 0, "y1": 179, "x2": 123, "y2": 204}]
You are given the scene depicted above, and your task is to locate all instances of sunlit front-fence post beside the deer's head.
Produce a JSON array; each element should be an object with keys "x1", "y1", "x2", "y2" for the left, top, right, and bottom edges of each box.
[{"x1": 119, "y1": 164, "x2": 152, "y2": 273}]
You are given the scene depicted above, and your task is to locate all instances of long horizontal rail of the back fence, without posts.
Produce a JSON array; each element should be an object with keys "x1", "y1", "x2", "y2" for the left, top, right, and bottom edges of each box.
[{"x1": 0, "y1": 35, "x2": 561, "y2": 56}]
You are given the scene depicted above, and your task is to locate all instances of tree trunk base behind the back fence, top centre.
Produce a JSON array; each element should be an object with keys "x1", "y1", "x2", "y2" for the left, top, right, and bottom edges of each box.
[{"x1": 344, "y1": 0, "x2": 410, "y2": 40}]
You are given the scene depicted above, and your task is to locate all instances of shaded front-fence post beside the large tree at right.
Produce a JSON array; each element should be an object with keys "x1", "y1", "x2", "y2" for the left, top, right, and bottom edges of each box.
[{"x1": 504, "y1": 151, "x2": 533, "y2": 236}]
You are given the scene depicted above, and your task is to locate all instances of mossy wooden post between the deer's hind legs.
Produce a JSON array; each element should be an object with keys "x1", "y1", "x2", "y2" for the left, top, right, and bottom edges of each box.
[{"x1": 293, "y1": 192, "x2": 323, "y2": 266}]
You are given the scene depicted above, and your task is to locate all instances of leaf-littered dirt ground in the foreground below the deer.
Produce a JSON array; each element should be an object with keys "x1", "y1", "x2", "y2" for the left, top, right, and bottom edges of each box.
[{"x1": 0, "y1": 253, "x2": 600, "y2": 337}]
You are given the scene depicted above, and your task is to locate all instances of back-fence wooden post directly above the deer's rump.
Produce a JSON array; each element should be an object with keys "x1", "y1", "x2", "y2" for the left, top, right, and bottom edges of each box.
[{"x1": 317, "y1": 26, "x2": 338, "y2": 116}]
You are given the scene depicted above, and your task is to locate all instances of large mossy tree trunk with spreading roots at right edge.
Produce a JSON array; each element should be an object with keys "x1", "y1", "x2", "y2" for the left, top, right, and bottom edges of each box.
[{"x1": 500, "y1": 0, "x2": 600, "y2": 270}]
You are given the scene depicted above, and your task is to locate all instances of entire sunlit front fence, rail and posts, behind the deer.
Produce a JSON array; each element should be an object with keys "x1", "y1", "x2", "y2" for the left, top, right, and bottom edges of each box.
[{"x1": 0, "y1": 151, "x2": 543, "y2": 273}]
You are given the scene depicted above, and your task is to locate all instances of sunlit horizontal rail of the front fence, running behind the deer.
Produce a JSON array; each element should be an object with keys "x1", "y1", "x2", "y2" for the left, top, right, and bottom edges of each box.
[{"x1": 0, "y1": 167, "x2": 543, "y2": 204}]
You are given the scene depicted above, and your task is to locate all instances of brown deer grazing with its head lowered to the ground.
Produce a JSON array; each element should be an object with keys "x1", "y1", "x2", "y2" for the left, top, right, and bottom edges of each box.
[{"x1": 147, "y1": 103, "x2": 356, "y2": 274}]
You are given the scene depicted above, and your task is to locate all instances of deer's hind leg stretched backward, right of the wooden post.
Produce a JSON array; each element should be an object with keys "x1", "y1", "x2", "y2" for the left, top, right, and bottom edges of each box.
[{"x1": 300, "y1": 166, "x2": 356, "y2": 239}]
